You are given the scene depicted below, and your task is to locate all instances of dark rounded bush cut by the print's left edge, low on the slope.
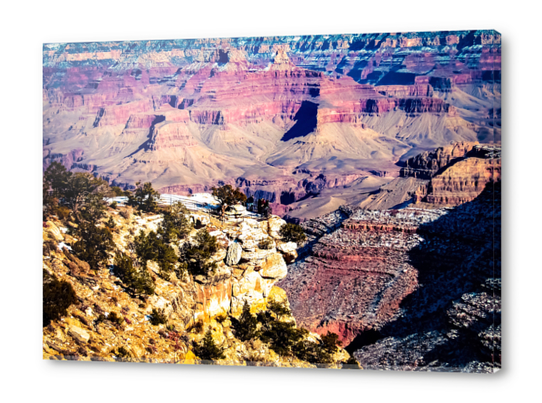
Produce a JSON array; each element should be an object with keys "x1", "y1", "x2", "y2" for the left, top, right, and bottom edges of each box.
[{"x1": 43, "y1": 271, "x2": 78, "y2": 326}]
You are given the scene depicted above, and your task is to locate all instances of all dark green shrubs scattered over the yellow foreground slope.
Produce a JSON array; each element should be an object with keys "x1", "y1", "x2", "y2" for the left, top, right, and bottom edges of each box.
[{"x1": 44, "y1": 169, "x2": 344, "y2": 363}]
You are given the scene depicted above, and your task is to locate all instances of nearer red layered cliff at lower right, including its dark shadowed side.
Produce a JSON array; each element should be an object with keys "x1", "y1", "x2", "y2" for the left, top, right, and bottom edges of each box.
[{"x1": 279, "y1": 182, "x2": 501, "y2": 372}]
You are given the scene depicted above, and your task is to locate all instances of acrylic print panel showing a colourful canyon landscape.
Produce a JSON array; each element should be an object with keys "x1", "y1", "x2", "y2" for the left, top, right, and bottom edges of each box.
[{"x1": 43, "y1": 31, "x2": 501, "y2": 372}]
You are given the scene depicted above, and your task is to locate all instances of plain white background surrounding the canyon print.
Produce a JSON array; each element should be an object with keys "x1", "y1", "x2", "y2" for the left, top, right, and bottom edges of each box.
[{"x1": 0, "y1": 0, "x2": 542, "y2": 402}]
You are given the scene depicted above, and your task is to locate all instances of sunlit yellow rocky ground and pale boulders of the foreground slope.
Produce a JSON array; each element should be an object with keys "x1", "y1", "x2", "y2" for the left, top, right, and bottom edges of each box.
[{"x1": 43, "y1": 207, "x2": 349, "y2": 368}]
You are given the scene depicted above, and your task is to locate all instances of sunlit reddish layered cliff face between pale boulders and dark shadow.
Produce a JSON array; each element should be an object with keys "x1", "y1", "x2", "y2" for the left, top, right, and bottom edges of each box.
[{"x1": 279, "y1": 208, "x2": 444, "y2": 345}]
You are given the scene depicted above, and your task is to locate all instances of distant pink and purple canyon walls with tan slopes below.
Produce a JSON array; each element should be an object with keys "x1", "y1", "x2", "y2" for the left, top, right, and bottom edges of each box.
[{"x1": 43, "y1": 31, "x2": 500, "y2": 219}]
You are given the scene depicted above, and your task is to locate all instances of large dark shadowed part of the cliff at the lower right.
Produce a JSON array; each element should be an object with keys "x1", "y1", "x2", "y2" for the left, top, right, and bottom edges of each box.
[{"x1": 362, "y1": 182, "x2": 501, "y2": 372}]
